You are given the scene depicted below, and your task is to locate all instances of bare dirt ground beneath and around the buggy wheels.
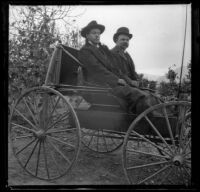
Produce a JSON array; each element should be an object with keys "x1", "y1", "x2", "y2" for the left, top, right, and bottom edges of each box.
[{"x1": 8, "y1": 140, "x2": 128, "y2": 187}]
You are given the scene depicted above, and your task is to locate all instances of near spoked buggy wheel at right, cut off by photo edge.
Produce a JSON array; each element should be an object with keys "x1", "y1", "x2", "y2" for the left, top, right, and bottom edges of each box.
[{"x1": 123, "y1": 101, "x2": 191, "y2": 185}]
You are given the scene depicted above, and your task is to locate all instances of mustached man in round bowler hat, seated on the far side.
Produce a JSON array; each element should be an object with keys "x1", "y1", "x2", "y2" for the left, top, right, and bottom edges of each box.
[{"x1": 111, "y1": 27, "x2": 138, "y2": 87}]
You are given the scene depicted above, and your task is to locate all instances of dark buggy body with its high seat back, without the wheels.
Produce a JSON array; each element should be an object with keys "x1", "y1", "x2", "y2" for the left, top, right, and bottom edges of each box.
[{"x1": 45, "y1": 45, "x2": 175, "y2": 134}]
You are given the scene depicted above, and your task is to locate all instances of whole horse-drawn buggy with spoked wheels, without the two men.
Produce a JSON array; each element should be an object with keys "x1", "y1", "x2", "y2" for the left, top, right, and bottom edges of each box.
[{"x1": 9, "y1": 44, "x2": 191, "y2": 185}]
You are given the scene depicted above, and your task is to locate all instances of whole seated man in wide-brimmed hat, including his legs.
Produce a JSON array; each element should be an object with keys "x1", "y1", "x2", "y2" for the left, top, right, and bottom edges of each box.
[{"x1": 79, "y1": 21, "x2": 157, "y2": 113}]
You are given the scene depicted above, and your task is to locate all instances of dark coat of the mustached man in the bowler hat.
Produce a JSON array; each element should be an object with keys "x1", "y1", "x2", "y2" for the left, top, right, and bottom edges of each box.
[{"x1": 111, "y1": 46, "x2": 138, "y2": 83}]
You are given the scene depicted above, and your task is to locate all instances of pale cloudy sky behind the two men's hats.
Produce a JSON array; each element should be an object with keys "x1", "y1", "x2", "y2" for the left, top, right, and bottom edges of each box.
[{"x1": 72, "y1": 4, "x2": 191, "y2": 75}]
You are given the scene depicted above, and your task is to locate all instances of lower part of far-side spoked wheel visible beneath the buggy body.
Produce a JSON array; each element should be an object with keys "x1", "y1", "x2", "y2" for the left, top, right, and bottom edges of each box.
[{"x1": 81, "y1": 128, "x2": 124, "y2": 153}]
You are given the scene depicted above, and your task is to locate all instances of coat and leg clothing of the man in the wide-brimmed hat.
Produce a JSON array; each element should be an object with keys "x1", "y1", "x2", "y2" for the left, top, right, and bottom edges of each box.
[{"x1": 79, "y1": 41, "x2": 153, "y2": 112}]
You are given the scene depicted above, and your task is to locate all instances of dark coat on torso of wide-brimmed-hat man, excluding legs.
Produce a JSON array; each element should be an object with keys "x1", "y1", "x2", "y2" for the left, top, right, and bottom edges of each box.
[{"x1": 79, "y1": 43, "x2": 119, "y2": 88}]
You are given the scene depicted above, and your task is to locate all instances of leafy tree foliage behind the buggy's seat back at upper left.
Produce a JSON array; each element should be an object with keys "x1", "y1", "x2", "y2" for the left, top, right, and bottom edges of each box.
[{"x1": 9, "y1": 6, "x2": 81, "y2": 102}]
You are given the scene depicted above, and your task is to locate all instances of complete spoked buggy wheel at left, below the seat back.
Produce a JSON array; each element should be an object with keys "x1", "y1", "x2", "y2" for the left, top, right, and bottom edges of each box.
[{"x1": 9, "y1": 87, "x2": 81, "y2": 180}]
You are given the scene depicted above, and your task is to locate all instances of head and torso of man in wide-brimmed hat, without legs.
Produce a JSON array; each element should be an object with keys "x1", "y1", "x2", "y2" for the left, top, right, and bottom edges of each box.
[{"x1": 79, "y1": 21, "x2": 119, "y2": 87}]
